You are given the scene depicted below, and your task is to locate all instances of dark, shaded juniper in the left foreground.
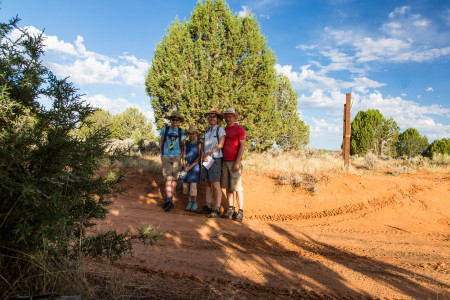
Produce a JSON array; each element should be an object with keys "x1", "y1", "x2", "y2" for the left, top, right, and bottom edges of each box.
[{"x1": 0, "y1": 18, "x2": 162, "y2": 299}]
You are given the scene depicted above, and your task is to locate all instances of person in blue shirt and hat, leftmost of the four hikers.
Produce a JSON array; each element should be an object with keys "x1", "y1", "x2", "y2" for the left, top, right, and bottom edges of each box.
[{"x1": 159, "y1": 111, "x2": 186, "y2": 211}]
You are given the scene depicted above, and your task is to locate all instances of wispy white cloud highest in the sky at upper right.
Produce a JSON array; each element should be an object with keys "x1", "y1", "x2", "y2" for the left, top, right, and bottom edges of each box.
[{"x1": 296, "y1": 6, "x2": 450, "y2": 75}]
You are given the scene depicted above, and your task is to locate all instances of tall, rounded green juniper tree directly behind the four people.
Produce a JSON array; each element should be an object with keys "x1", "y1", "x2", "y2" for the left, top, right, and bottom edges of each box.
[{"x1": 146, "y1": 0, "x2": 308, "y2": 150}]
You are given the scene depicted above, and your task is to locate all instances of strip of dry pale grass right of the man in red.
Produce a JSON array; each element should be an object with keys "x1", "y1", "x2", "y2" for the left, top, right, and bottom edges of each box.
[{"x1": 245, "y1": 148, "x2": 450, "y2": 194}]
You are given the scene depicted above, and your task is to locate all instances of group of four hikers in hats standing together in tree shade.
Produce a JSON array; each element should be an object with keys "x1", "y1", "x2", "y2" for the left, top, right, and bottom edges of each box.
[{"x1": 156, "y1": 108, "x2": 246, "y2": 222}]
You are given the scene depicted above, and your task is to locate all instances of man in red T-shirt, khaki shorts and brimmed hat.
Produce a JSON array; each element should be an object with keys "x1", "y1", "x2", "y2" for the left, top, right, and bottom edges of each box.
[{"x1": 221, "y1": 108, "x2": 245, "y2": 222}]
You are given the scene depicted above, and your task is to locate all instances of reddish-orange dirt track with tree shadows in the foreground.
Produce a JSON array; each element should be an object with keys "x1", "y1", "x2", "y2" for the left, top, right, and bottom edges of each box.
[{"x1": 92, "y1": 171, "x2": 450, "y2": 299}]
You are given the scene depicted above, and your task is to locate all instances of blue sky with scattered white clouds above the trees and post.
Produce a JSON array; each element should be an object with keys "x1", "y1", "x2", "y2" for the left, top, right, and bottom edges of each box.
[{"x1": 0, "y1": 0, "x2": 450, "y2": 150}]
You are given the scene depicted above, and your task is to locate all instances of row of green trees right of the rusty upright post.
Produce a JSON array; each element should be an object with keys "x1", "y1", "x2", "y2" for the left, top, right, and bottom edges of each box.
[{"x1": 350, "y1": 109, "x2": 450, "y2": 158}]
